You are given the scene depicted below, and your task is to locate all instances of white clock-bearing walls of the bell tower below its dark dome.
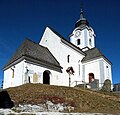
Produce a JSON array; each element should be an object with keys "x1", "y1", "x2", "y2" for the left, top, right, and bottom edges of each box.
[{"x1": 70, "y1": 26, "x2": 95, "y2": 49}]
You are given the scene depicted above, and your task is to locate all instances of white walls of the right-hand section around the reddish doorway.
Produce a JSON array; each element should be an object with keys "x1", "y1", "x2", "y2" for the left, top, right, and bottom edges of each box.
[{"x1": 83, "y1": 58, "x2": 112, "y2": 84}]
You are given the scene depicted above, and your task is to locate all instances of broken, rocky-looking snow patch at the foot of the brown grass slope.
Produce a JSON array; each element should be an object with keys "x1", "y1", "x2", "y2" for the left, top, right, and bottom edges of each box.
[{"x1": 12, "y1": 101, "x2": 74, "y2": 112}]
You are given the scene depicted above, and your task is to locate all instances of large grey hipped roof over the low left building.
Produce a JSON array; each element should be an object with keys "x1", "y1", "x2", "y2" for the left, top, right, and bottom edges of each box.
[{"x1": 3, "y1": 39, "x2": 62, "y2": 70}]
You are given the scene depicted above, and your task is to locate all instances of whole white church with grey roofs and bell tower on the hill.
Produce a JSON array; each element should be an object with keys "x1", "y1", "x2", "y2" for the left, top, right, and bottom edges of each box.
[{"x1": 3, "y1": 10, "x2": 112, "y2": 89}]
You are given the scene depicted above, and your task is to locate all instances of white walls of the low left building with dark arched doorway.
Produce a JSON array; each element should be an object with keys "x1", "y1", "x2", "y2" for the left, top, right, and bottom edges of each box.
[{"x1": 3, "y1": 60, "x2": 61, "y2": 89}]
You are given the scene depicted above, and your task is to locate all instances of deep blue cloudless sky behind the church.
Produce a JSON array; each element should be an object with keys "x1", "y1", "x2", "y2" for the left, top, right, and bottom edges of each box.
[{"x1": 0, "y1": 0, "x2": 120, "y2": 86}]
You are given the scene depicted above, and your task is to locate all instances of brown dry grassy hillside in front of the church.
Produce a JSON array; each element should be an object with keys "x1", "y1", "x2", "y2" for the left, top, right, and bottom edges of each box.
[{"x1": 6, "y1": 84, "x2": 120, "y2": 114}]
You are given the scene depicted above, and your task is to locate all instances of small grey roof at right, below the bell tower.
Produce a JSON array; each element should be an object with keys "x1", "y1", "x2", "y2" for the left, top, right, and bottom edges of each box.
[{"x1": 82, "y1": 48, "x2": 111, "y2": 64}]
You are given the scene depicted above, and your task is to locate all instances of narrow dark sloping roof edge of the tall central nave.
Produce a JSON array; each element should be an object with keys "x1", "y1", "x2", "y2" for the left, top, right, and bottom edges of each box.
[{"x1": 49, "y1": 27, "x2": 85, "y2": 56}]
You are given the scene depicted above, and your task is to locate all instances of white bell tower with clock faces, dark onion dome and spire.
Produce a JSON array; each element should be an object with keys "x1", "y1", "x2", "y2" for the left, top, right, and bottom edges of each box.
[{"x1": 70, "y1": 9, "x2": 95, "y2": 51}]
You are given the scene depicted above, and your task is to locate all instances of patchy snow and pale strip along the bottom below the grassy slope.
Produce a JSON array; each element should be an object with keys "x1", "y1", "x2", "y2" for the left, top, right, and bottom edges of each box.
[{"x1": 0, "y1": 101, "x2": 112, "y2": 115}]
